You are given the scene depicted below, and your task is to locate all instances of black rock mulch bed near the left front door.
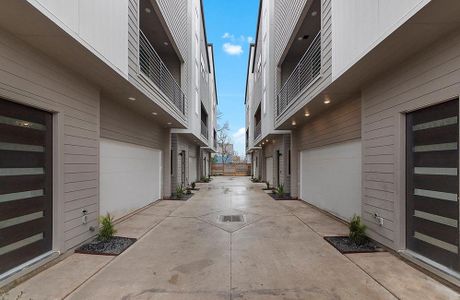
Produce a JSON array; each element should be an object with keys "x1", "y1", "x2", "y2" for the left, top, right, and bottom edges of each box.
[{"x1": 75, "y1": 236, "x2": 136, "y2": 256}]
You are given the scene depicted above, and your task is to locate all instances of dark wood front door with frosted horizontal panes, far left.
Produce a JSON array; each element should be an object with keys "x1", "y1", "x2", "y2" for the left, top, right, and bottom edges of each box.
[{"x1": 0, "y1": 99, "x2": 53, "y2": 273}]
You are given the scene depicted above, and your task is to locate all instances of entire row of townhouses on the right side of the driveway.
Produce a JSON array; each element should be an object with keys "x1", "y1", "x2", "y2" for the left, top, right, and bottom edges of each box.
[{"x1": 245, "y1": 0, "x2": 460, "y2": 284}]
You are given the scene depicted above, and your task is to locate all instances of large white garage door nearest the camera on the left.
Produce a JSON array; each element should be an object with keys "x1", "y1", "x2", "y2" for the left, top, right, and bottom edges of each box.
[{"x1": 100, "y1": 139, "x2": 162, "y2": 218}]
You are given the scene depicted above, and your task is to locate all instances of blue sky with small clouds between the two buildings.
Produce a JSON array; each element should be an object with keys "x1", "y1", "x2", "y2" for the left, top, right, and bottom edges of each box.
[{"x1": 203, "y1": 0, "x2": 259, "y2": 155}]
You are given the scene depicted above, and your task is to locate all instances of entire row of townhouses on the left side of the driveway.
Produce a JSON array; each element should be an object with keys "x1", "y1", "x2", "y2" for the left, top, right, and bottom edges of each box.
[{"x1": 0, "y1": 0, "x2": 217, "y2": 282}]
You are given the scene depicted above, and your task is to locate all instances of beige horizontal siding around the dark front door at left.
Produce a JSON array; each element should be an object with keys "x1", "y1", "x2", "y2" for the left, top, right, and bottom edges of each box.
[{"x1": 0, "y1": 30, "x2": 99, "y2": 250}]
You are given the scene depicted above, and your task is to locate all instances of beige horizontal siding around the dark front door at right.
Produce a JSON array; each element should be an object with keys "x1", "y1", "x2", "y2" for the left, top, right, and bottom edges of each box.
[{"x1": 362, "y1": 27, "x2": 460, "y2": 248}]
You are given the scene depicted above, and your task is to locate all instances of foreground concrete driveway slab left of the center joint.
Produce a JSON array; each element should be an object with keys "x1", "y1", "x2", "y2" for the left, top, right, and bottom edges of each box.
[{"x1": 69, "y1": 218, "x2": 230, "y2": 299}]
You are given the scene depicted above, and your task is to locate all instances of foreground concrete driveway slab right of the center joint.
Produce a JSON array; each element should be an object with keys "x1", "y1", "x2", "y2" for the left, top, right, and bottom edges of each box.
[{"x1": 232, "y1": 216, "x2": 395, "y2": 299}]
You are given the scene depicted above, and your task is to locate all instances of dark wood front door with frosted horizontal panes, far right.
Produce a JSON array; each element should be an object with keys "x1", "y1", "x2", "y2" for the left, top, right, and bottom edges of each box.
[{"x1": 406, "y1": 99, "x2": 460, "y2": 270}]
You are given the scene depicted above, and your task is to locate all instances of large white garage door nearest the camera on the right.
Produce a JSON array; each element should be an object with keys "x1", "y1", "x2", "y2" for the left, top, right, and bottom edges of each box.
[{"x1": 300, "y1": 141, "x2": 361, "y2": 220}]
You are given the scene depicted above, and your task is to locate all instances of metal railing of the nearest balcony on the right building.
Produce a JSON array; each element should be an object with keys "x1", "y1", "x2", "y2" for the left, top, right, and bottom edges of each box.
[{"x1": 276, "y1": 32, "x2": 321, "y2": 116}]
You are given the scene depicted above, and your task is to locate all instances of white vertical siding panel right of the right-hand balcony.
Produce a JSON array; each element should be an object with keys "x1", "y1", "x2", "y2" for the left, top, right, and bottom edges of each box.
[{"x1": 332, "y1": 0, "x2": 430, "y2": 79}]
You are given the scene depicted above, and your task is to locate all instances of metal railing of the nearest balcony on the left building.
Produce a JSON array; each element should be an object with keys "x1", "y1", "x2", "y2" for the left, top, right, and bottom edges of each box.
[{"x1": 139, "y1": 30, "x2": 186, "y2": 115}]
